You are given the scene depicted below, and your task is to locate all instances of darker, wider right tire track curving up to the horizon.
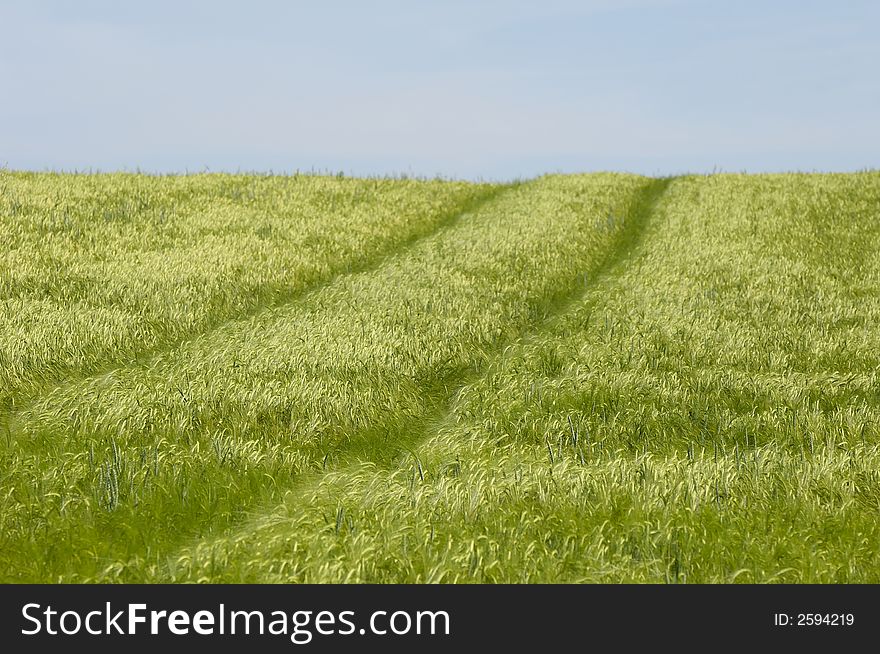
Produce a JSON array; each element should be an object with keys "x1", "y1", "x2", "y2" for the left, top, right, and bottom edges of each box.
[{"x1": 148, "y1": 177, "x2": 674, "y2": 581}]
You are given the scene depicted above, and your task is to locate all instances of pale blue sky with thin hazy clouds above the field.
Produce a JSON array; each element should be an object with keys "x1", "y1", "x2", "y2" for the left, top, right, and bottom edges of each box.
[{"x1": 0, "y1": 0, "x2": 880, "y2": 180}]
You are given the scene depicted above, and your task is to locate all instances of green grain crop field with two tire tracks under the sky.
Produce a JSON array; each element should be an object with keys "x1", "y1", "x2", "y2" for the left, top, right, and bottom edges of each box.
[{"x1": 0, "y1": 170, "x2": 880, "y2": 583}]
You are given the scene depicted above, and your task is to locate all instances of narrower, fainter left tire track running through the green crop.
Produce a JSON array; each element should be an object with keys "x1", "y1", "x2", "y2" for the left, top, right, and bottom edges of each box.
[{"x1": 0, "y1": 182, "x2": 523, "y2": 439}]
